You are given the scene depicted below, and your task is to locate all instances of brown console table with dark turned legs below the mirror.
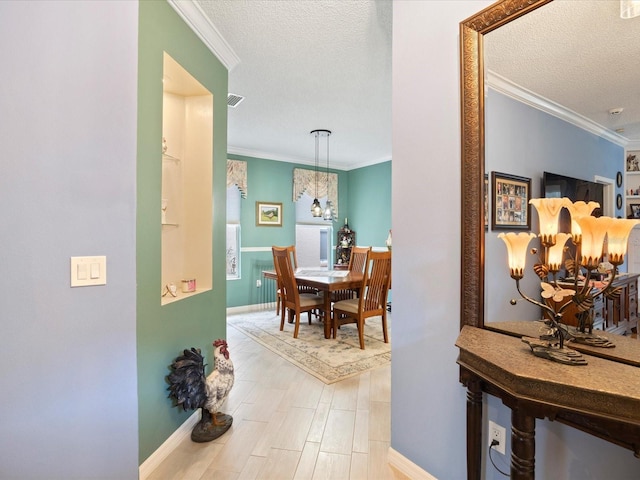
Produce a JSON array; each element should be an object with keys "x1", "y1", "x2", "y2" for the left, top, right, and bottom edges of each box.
[{"x1": 456, "y1": 326, "x2": 640, "y2": 480}]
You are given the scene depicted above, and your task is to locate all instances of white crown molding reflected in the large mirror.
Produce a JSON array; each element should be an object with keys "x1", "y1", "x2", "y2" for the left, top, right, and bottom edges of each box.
[{"x1": 485, "y1": 71, "x2": 629, "y2": 147}]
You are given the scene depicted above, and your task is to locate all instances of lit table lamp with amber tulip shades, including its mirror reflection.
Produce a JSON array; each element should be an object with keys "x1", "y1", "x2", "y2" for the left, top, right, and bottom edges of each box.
[{"x1": 498, "y1": 198, "x2": 640, "y2": 365}]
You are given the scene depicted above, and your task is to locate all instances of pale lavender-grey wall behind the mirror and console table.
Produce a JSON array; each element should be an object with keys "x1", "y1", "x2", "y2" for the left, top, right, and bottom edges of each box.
[{"x1": 391, "y1": 0, "x2": 638, "y2": 480}]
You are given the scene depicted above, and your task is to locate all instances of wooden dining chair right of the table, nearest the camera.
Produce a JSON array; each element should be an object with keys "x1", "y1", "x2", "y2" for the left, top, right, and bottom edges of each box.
[{"x1": 331, "y1": 251, "x2": 391, "y2": 350}]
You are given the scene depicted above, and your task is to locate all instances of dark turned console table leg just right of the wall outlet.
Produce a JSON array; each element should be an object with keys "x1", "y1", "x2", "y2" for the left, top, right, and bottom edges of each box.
[{"x1": 511, "y1": 408, "x2": 536, "y2": 480}]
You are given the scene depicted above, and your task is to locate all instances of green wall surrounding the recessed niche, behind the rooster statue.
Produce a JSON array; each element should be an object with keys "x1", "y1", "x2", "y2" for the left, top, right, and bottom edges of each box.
[{"x1": 136, "y1": 1, "x2": 233, "y2": 463}]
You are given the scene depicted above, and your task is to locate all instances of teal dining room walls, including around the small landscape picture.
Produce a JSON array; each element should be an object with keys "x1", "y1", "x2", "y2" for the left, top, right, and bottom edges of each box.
[{"x1": 227, "y1": 155, "x2": 391, "y2": 307}]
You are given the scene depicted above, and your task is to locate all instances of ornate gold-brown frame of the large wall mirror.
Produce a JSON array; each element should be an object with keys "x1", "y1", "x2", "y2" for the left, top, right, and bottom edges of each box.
[{"x1": 460, "y1": 0, "x2": 551, "y2": 328}]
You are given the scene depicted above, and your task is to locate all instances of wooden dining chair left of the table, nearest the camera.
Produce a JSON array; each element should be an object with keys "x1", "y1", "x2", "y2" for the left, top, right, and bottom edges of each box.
[{"x1": 272, "y1": 247, "x2": 324, "y2": 338}]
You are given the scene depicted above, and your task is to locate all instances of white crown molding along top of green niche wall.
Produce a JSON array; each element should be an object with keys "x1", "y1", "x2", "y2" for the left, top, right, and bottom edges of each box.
[{"x1": 167, "y1": 0, "x2": 240, "y2": 71}]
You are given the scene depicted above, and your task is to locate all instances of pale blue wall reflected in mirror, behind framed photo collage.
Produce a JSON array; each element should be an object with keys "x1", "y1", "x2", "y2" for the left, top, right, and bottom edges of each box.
[{"x1": 485, "y1": 89, "x2": 624, "y2": 321}]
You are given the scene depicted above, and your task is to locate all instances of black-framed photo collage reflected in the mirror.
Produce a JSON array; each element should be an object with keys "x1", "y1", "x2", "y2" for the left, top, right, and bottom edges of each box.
[{"x1": 491, "y1": 172, "x2": 531, "y2": 230}]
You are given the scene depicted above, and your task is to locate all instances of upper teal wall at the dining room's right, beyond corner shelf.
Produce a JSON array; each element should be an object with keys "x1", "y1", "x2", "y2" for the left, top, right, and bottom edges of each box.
[{"x1": 347, "y1": 161, "x2": 391, "y2": 247}]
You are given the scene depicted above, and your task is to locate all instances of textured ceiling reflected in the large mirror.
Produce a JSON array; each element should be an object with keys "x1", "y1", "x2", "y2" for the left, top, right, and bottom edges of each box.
[{"x1": 485, "y1": 0, "x2": 640, "y2": 142}]
